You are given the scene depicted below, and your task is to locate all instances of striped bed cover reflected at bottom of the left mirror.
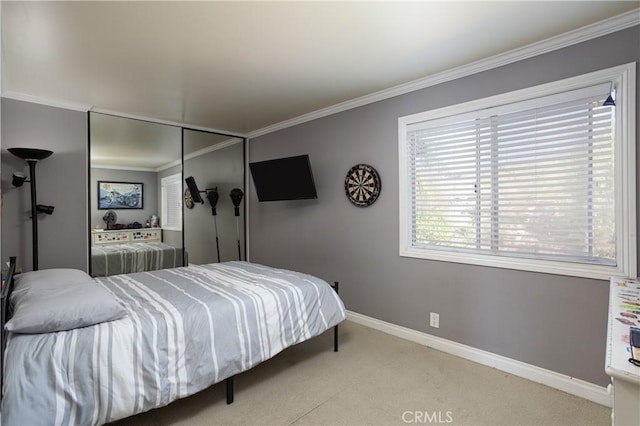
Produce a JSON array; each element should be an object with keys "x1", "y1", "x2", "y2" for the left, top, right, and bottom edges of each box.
[{"x1": 91, "y1": 242, "x2": 182, "y2": 277}]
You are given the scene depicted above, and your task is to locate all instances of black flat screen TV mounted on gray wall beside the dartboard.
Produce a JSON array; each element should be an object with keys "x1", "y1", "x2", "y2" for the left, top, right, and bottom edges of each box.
[{"x1": 249, "y1": 155, "x2": 318, "y2": 201}]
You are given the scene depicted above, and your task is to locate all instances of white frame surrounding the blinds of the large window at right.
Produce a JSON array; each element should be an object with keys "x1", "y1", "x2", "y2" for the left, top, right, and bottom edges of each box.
[{"x1": 398, "y1": 62, "x2": 637, "y2": 279}]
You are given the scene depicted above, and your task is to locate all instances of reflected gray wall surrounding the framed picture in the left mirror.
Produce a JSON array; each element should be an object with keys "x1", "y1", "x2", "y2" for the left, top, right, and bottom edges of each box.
[{"x1": 89, "y1": 168, "x2": 160, "y2": 229}]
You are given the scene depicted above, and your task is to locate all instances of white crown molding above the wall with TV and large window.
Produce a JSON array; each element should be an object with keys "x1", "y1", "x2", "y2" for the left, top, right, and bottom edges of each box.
[{"x1": 247, "y1": 8, "x2": 640, "y2": 138}]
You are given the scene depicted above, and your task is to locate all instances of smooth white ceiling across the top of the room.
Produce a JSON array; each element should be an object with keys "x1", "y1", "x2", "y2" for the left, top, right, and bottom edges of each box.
[{"x1": 0, "y1": 1, "x2": 640, "y2": 134}]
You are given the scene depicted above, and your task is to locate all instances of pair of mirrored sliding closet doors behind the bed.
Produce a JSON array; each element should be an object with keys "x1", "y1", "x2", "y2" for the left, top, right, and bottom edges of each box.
[{"x1": 89, "y1": 112, "x2": 245, "y2": 276}]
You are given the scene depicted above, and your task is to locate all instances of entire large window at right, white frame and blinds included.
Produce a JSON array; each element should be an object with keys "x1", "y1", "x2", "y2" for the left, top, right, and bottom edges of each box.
[{"x1": 399, "y1": 64, "x2": 636, "y2": 279}]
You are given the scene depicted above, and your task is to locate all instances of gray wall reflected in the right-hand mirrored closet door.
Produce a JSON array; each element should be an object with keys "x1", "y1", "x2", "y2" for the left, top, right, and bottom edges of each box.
[{"x1": 184, "y1": 141, "x2": 245, "y2": 264}]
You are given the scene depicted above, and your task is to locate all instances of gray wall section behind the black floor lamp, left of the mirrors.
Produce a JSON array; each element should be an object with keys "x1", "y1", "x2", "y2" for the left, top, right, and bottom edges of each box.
[{"x1": 1, "y1": 99, "x2": 89, "y2": 271}]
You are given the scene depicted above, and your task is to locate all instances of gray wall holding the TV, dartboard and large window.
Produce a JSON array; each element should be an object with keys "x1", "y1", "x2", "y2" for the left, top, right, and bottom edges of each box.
[{"x1": 249, "y1": 27, "x2": 640, "y2": 386}]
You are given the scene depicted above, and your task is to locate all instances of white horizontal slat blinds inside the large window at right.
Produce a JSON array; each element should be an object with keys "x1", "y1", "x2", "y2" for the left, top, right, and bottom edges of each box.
[{"x1": 405, "y1": 83, "x2": 616, "y2": 265}]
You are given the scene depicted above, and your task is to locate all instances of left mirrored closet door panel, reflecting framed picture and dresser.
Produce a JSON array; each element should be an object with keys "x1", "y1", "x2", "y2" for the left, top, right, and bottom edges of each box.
[{"x1": 89, "y1": 112, "x2": 184, "y2": 277}]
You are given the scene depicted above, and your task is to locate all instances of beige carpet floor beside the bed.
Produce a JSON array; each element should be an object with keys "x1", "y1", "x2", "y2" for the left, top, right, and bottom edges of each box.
[{"x1": 117, "y1": 321, "x2": 611, "y2": 426}]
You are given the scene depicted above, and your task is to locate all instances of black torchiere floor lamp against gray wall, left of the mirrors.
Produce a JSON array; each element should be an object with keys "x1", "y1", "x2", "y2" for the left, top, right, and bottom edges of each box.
[{"x1": 8, "y1": 148, "x2": 54, "y2": 271}]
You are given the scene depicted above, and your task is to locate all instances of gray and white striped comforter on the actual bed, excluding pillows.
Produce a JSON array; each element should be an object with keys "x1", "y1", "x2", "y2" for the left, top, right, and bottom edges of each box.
[{"x1": 2, "y1": 262, "x2": 345, "y2": 426}]
